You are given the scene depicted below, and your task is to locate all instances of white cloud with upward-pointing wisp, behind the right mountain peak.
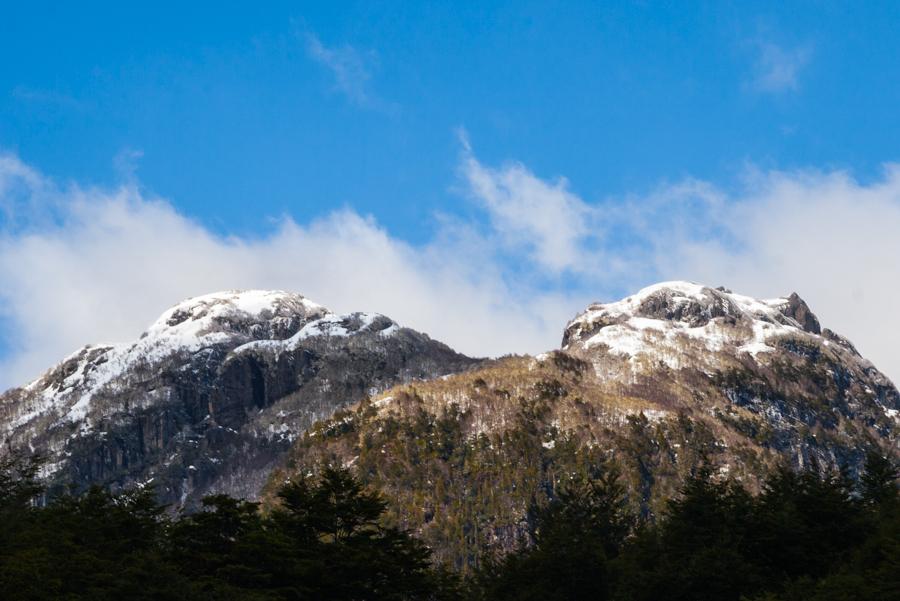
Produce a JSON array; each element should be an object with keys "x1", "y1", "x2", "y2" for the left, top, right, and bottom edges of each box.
[{"x1": 463, "y1": 150, "x2": 900, "y2": 379}]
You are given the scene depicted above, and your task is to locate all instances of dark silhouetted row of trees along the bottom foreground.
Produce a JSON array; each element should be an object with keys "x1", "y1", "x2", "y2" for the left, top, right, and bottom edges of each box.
[{"x1": 0, "y1": 454, "x2": 900, "y2": 601}]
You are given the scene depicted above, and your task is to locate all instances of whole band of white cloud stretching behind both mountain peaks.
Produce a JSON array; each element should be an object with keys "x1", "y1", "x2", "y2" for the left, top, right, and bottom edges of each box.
[{"x1": 0, "y1": 147, "x2": 900, "y2": 388}]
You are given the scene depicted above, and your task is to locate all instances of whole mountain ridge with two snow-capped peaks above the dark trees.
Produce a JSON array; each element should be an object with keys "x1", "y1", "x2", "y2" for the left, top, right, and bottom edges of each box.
[{"x1": 0, "y1": 282, "x2": 900, "y2": 544}]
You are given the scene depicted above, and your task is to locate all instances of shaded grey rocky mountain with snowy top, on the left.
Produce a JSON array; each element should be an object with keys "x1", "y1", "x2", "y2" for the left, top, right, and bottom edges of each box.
[{"x1": 0, "y1": 291, "x2": 476, "y2": 508}]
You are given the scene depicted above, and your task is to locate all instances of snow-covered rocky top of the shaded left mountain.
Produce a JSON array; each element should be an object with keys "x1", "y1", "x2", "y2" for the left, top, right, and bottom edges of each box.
[{"x1": 0, "y1": 290, "x2": 399, "y2": 433}]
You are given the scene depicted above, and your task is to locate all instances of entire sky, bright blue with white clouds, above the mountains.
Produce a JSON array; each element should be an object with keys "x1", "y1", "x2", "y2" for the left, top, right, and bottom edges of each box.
[{"x1": 0, "y1": 2, "x2": 900, "y2": 387}]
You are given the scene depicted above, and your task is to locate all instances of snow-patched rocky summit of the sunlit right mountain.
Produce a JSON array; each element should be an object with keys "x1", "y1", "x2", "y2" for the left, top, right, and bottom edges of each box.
[{"x1": 563, "y1": 282, "x2": 900, "y2": 468}]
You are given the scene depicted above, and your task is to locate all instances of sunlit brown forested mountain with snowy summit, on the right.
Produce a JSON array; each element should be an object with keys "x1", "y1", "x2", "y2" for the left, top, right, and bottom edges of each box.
[{"x1": 271, "y1": 282, "x2": 900, "y2": 566}]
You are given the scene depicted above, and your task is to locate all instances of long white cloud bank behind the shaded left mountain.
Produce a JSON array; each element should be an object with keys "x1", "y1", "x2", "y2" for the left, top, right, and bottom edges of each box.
[{"x1": 0, "y1": 157, "x2": 586, "y2": 388}]
